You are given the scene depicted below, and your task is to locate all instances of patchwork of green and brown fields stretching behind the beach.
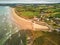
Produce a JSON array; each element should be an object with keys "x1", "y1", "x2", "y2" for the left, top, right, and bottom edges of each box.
[{"x1": 15, "y1": 4, "x2": 60, "y2": 18}]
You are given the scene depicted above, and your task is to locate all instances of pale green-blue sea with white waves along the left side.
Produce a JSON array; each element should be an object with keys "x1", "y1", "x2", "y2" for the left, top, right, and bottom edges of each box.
[{"x1": 0, "y1": 6, "x2": 18, "y2": 45}]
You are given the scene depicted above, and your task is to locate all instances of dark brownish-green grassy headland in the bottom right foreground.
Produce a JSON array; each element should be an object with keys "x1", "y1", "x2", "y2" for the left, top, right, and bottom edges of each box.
[{"x1": 32, "y1": 31, "x2": 60, "y2": 45}]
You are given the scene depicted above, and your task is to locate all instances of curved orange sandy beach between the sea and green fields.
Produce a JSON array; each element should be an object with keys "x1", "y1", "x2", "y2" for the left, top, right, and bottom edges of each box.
[{"x1": 11, "y1": 8, "x2": 49, "y2": 30}]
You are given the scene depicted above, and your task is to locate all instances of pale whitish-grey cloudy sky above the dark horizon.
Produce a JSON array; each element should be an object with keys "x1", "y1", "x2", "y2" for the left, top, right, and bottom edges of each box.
[{"x1": 0, "y1": 0, "x2": 60, "y2": 3}]
